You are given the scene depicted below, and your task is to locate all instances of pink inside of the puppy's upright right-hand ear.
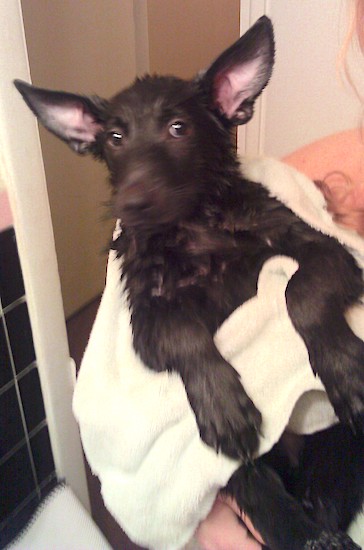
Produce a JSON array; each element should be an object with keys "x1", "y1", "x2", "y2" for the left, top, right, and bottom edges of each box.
[{"x1": 215, "y1": 58, "x2": 260, "y2": 118}]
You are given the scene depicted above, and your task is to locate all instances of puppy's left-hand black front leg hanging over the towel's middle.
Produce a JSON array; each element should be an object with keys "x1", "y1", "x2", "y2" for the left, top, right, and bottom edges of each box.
[{"x1": 132, "y1": 297, "x2": 261, "y2": 460}]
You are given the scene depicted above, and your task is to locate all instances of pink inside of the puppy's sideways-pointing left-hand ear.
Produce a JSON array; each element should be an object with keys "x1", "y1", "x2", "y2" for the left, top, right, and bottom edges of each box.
[{"x1": 51, "y1": 104, "x2": 102, "y2": 143}]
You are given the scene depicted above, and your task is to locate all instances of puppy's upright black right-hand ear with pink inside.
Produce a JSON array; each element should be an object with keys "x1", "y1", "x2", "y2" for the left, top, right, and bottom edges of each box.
[{"x1": 202, "y1": 16, "x2": 274, "y2": 124}]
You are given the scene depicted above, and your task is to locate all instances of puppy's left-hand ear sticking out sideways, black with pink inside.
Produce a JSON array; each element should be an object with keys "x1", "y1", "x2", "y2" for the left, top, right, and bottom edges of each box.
[{"x1": 14, "y1": 80, "x2": 106, "y2": 154}]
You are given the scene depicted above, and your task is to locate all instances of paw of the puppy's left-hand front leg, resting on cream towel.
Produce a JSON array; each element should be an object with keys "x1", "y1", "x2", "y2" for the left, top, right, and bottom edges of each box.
[{"x1": 186, "y1": 363, "x2": 262, "y2": 462}]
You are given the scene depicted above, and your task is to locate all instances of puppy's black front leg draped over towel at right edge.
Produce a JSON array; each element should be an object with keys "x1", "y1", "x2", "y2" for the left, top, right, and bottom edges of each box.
[{"x1": 286, "y1": 244, "x2": 364, "y2": 430}]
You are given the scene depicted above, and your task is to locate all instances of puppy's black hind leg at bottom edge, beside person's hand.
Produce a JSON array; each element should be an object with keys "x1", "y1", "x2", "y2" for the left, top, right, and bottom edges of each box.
[{"x1": 225, "y1": 459, "x2": 360, "y2": 550}]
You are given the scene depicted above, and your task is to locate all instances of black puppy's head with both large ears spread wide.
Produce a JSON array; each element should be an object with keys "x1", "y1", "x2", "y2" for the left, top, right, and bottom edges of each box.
[{"x1": 15, "y1": 17, "x2": 274, "y2": 230}]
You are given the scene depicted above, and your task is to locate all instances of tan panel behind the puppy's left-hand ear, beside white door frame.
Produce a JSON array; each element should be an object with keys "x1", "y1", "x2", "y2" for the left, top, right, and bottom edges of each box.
[{"x1": 22, "y1": 0, "x2": 136, "y2": 317}]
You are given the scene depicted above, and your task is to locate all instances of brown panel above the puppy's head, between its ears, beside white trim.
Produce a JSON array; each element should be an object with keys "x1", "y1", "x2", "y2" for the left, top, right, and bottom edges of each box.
[{"x1": 148, "y1": 0, "x2": 239, "y2": 78}]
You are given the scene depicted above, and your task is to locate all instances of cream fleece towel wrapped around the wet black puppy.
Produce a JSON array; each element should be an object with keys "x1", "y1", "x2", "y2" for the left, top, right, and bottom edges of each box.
[{"x1": 73, "y1": 159, "x2": 364, "y2": 550}]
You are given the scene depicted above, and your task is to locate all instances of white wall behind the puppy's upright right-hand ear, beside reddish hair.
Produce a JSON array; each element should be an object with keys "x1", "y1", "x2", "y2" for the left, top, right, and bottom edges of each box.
[{"x1": 239, "y1": 0, "x2": 364, "y2": 157}]
